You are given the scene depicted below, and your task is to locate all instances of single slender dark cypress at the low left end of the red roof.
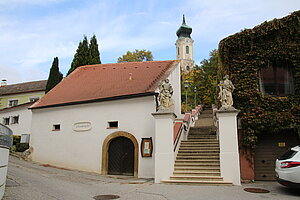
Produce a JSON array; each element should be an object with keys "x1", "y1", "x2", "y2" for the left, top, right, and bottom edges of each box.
[{"x1": 45, "y1": 57, "x2": 63, "y2": 93}]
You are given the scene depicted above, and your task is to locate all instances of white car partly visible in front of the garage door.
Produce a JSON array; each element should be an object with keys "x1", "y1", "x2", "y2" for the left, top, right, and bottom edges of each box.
[{"x1": 275, "y1": 145, "x2": 300, "y2": 188}]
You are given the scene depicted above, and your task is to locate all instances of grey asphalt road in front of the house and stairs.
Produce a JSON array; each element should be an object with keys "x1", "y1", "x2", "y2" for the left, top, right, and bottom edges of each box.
[{"x1": 3, "y1": 156, "x2": 300, "y2": 200}]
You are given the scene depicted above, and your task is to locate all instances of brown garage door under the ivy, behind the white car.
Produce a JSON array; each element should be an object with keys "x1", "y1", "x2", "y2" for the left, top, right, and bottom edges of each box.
[{"x1": 254, "y1": 130, "x2": 300, "y2": 181}]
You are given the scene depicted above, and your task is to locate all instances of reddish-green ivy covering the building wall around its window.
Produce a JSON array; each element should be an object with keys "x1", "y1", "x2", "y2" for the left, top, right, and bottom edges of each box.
[{"x1": 218, "y1": 11, "x2": 300, "y2": 148}]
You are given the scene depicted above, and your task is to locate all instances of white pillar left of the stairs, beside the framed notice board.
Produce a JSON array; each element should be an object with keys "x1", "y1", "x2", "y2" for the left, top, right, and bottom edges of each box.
[{"x1": 152, "y1": 112, "x2": 176, "y2": 183}]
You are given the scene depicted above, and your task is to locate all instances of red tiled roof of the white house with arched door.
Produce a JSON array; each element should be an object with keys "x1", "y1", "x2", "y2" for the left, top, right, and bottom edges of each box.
[{"x1": 31, "y1": 60, "x2": 178, "y2": 108}]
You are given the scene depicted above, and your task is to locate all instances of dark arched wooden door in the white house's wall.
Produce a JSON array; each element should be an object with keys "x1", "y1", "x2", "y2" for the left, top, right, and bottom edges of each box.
[{"x1": 108, "y1": 137, "x2": 134, "y2": 176}]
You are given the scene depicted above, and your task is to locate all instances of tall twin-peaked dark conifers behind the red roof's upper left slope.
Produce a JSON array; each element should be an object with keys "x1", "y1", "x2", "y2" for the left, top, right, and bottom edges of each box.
[{"x1": 67, "y1": 35, "x2": 101, "y2": 75}]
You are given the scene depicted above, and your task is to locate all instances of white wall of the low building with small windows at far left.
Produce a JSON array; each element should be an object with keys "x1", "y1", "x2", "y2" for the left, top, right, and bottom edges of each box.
[{"x1": 0, "y1": 106, "x2": 32, "y2": 136}]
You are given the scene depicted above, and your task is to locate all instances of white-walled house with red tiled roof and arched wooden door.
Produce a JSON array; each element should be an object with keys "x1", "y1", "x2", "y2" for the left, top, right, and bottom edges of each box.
[{"x1": 30, "y1": 61, "x2": 181, "y2": 178}]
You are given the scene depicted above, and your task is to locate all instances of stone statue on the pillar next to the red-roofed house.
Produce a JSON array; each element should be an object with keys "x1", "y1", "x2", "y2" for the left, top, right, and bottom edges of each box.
[{"x1": 158, "y1": 79, "x2": 173, "y2": 111}]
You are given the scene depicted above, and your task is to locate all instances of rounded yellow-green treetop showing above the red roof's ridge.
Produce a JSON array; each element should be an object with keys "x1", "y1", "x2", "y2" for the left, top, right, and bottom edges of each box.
[{"x1": 118, "y1": 49, "x2": 153, "y2": 63}]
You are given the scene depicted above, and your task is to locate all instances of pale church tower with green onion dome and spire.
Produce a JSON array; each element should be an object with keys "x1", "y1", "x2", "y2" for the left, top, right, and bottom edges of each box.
[{"x1": 175, "y1": 15, "x2": 194, "y2": 73}]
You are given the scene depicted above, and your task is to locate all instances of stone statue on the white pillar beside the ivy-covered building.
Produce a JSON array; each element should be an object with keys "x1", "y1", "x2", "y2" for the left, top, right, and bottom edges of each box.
[{"x1": 219, "y1": 75, "x2": 235, "y2": 110}]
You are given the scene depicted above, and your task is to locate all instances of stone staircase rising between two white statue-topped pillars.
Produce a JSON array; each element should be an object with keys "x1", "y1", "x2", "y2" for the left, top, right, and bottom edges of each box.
[{"x1": 162, "y1": 109, "x2": 232, "y2": 185}]
